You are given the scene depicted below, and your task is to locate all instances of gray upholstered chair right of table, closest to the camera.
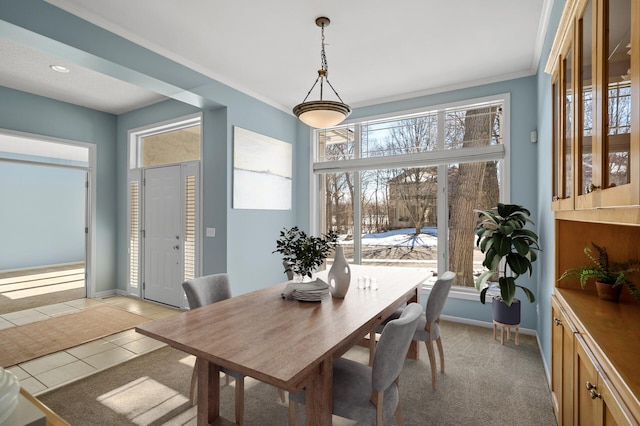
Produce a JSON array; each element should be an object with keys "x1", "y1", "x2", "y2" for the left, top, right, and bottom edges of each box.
[{"x1": 289, "y1": 303, "x2": 422, "y2": 426}]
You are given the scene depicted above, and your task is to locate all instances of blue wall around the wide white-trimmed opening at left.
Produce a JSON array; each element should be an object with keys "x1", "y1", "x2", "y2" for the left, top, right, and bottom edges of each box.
[{"x1": 0, "y1": 86, "x2": 117, "y2": 292}]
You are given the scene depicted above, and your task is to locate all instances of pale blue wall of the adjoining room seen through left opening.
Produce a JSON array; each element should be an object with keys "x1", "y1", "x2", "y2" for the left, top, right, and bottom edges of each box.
[{"x1": 0, "y1": 162, "x2": 87, "y2": 271}]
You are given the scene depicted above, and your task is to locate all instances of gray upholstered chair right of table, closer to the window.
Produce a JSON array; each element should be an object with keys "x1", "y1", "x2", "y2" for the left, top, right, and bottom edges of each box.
[{"x1": 369, "y1": 271, "x2": 456, "y2": 389}]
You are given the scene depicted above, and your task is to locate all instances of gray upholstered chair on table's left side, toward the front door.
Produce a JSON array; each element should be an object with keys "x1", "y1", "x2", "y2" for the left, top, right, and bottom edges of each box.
[{"x1": 182, "y1": 274, "x2": 285, "y2": 425}]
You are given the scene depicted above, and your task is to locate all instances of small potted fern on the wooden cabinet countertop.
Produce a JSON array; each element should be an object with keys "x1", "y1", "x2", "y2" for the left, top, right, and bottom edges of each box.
[{"x1": 558, "y1": 242, "x2": 640, "y2": 302}]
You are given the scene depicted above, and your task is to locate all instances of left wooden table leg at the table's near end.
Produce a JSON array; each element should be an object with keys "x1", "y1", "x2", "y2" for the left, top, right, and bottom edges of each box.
[{"x1": 197, "y1": 359, "x2": 220, "y2": 426}]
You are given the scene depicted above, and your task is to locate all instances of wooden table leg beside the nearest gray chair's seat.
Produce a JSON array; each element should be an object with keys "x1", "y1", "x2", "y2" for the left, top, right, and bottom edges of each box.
[{"x1": 306, "y1": 360, "x2": 333, "y2": 426}]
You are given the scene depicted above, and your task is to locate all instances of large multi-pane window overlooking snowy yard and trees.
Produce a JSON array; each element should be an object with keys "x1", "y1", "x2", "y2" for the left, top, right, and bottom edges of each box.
[{"x1": 314, "y1": 95, "x2": 508, "y2": 287}]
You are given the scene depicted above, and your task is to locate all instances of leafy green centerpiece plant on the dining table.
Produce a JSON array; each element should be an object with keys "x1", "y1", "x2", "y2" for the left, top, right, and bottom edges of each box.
[{"x1": 273, "y1": 226, "x2": 338, "y2": 278}]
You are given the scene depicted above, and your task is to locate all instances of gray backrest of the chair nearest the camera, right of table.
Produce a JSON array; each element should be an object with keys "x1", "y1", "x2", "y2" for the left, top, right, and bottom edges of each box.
[{"x1": 372, "y1": 303, "x2": 422, "y2": 392}]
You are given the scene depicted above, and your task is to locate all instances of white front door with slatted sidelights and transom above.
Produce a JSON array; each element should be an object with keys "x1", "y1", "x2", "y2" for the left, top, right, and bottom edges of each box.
[{"x1": 127, "y1": 115, "x2": 201, "y2": 308}]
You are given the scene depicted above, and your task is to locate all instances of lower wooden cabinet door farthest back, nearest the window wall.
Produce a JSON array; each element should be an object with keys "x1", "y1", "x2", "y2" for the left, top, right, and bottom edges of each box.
[{"x1": 551, "y1": 298, "x2": 577, "y2": 426}]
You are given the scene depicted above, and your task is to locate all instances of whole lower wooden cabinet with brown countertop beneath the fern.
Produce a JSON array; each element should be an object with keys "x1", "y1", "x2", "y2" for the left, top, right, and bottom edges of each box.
[{"x1": 551, "y1": 289, "x2": 640, "y2": 426}]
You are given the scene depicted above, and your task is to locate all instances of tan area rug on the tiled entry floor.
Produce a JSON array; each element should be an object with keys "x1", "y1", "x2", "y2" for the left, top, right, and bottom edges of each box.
[{"x1": 0, "y1": 306, "x2": 151, "y2": 368}]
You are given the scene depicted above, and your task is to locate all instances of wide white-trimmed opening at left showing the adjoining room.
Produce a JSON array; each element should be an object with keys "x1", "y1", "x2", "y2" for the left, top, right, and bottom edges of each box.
[{"x1": 0, "y1": 129, "x2": 95, "y2": 313}]
